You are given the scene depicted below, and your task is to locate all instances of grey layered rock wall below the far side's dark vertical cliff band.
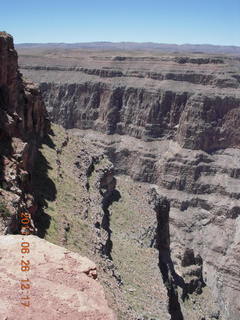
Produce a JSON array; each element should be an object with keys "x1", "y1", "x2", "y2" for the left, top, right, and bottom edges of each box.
[{"x1": 73, "y1": 130, "x2": 240, "y2": 320}]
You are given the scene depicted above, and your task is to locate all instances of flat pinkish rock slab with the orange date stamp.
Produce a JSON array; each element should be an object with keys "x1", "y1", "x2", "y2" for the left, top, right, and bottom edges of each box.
[{"x1": 0, "y1": 235, "x2": 116, "y2": 320}]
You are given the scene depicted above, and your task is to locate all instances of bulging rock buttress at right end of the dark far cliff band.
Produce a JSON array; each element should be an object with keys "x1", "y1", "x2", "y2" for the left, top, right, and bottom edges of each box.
[{"x1": 177, "y1": 95, "x2": 240, "y2": 151}]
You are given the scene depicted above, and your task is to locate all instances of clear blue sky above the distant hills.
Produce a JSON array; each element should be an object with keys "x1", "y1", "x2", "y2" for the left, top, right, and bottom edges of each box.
[{"x1": 0, "y1": 0, "x2": 240, "y2": 46}]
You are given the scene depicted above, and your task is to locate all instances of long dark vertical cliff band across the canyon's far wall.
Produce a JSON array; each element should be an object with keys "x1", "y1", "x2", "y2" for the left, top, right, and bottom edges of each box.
[{"x1": 40, "y1": 82, "x2": 240, "y2": 151}]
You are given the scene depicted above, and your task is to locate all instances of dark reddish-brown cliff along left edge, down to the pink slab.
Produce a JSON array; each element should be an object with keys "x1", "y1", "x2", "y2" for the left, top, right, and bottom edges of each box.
[{"x1": 0, "y1": 33, "x2": 49, "y2": 233}]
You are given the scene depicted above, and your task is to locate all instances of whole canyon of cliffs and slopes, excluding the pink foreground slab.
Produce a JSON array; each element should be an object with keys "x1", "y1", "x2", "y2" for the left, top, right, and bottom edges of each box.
[{"x1": 0, "y1": 35, "x2": 240, "y2": 320}]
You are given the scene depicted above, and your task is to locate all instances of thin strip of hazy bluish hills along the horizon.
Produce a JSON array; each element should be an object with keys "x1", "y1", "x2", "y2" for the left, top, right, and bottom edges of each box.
[{"x1": 16, "y1": 41, "x2": 240, "y2": 55}]
